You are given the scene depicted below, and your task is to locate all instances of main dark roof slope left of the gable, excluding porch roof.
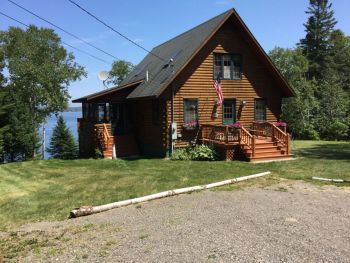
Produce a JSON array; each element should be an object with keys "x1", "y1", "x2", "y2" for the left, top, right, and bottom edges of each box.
[{"x1": 121, "y1": 10, "x2": 232, "y2": 99}]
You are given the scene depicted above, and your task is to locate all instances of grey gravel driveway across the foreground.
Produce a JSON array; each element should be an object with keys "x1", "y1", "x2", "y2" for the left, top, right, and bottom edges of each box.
[{"x1": 0, "y1": 181, "x2": 350, "y2": 262}]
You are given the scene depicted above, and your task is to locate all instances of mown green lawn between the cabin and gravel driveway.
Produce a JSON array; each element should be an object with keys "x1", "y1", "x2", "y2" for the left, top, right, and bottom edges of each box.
[{"x1": 0, "y1": 141, "x2": 350, "y2": 230}]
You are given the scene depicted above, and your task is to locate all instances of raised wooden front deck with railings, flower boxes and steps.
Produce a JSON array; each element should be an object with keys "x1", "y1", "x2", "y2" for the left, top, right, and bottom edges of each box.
[{"x1": 200, "y1": 122, "x2": 293, "y2": 162}]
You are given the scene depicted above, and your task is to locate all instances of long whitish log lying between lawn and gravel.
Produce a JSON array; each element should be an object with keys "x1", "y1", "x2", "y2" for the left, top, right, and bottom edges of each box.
[{"x1": 70, "y1": 172, "x2": 271, "y2": 218}]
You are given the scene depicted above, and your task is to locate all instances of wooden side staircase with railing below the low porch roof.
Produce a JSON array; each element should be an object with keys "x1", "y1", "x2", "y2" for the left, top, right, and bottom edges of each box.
[{"x1": 95, "y1": 123, "x2": 139, "y2": 159}]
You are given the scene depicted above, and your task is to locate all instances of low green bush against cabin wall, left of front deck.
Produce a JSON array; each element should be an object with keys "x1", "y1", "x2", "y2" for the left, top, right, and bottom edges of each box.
[{"x1": 171, "y1": 144, "x2": 217, "y2": 161}]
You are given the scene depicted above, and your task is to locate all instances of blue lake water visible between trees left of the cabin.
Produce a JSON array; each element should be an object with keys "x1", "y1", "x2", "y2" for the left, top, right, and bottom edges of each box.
[{"x1": 40, "y1": 112, "x2": 82, "y2": 159}]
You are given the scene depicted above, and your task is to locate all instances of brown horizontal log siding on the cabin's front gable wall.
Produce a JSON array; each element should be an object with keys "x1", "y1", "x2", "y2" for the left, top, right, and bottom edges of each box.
[{"x1": 167, "y1": 20, "x2": 282, "y2": 150}]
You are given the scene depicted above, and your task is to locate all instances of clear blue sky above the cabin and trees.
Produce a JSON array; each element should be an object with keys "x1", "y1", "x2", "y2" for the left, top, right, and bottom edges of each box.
[{"x1": 0, "y1": 0, "x2": 350, "y2": 106}]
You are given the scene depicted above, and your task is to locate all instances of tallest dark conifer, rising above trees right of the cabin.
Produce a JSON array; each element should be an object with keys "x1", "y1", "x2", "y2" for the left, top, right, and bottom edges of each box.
[{"x1": 299, "y1": 0, "x2": 337, "y2": 80}]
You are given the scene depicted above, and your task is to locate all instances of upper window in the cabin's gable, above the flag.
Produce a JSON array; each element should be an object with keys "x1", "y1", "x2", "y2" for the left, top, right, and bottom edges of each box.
[{"x1": 213, "y1": 53, "x2": 242, "y2": 79}]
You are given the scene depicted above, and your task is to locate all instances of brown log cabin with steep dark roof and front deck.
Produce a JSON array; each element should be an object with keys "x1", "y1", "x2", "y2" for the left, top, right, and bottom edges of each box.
[{"x1": 73, "y1": 9, "x2": 294, "y2": 161}]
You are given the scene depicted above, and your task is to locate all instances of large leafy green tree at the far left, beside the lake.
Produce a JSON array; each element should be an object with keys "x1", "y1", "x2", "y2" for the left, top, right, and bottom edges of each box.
[{"x1": 0, "y1": 26, "x2": 86, "y2": 159}]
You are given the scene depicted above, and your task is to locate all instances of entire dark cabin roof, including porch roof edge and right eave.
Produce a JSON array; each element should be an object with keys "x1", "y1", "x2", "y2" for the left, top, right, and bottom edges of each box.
[{"x1": 73, "y1": 9, "x2": 294, "y2": 102}]
